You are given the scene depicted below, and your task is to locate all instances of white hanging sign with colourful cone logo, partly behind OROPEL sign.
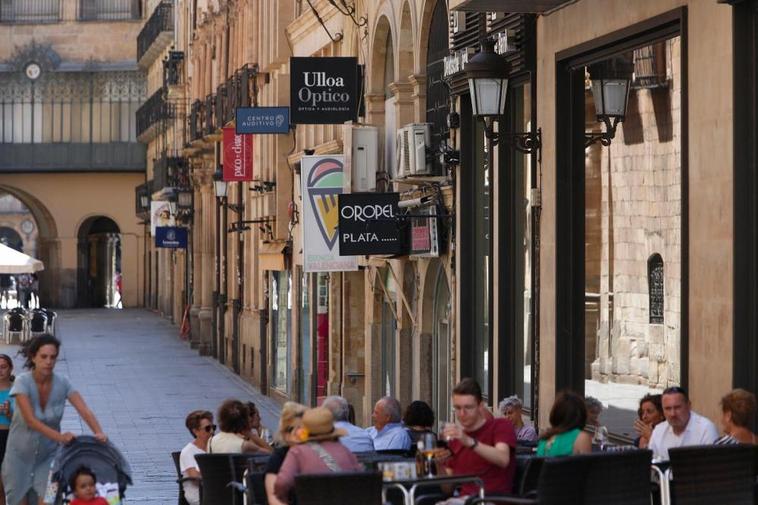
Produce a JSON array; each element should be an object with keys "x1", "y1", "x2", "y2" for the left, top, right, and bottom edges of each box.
[{"x1": 300, "y1": 155, "x2": 358, "y2": 272}]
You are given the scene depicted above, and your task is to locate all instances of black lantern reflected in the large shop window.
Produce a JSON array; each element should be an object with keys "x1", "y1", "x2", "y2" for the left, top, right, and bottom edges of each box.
[{"x1": 584, "y1": 54, "x2": 634, "y2": 147}]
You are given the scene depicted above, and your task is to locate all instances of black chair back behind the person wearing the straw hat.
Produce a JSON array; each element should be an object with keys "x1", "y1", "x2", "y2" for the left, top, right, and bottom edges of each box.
[{"x1": 295, "y1": 472, "x2": 382, "y2": 505}]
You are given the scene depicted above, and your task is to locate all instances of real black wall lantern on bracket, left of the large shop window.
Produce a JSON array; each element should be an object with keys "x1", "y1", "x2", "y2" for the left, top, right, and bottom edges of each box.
[{"x1": 463, "y1": 38, "x2": 542, "y2": 154}]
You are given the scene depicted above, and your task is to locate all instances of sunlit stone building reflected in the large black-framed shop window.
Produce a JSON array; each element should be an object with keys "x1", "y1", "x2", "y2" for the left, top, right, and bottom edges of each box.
[{"x1": 580, "y1": 37, "x2": 684, "y2": 438}]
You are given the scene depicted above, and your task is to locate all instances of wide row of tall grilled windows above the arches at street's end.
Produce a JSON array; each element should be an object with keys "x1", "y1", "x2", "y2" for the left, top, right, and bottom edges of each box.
[{"x1": 0, "y1": 72, "x2": 145, "y2": 144}]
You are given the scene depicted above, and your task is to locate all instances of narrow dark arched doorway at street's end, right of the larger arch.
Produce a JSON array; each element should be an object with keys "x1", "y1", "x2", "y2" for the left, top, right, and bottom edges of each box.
[{"x1": 76, "y1": 216, "x2": 122, "y2": 308}]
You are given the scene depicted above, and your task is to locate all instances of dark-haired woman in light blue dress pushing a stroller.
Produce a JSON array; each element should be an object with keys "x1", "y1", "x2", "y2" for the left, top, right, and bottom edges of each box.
[{"x1": 2, "y1": 335, "x2": 107, "y2": 505}]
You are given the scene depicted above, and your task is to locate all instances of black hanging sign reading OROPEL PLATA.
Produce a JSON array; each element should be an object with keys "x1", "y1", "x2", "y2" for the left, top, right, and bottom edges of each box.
[{"x1": 339, "y1": 193, "x2": 406, "y2": 256}]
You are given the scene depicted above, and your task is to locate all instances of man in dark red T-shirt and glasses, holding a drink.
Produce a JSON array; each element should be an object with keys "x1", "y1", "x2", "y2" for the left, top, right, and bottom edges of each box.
[{"x1": 441, "y1": 378, "x2": 516, "y2": 504}]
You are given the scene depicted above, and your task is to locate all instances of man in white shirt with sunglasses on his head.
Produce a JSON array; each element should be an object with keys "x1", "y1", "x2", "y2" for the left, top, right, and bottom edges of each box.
[{"x1": 648, "y1": 387, "x2": 719, "y2": 461}]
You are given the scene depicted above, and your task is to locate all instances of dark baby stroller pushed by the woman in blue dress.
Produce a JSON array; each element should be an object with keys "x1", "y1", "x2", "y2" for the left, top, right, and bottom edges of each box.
[{"x1": 45, "y1": 435, "x2": 132, "y2": 505}]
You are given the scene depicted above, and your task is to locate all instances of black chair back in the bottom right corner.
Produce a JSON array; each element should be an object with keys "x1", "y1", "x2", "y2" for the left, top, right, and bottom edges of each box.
[{"x1": 669, "y1": 445, "x2": 756, "y2": 505}]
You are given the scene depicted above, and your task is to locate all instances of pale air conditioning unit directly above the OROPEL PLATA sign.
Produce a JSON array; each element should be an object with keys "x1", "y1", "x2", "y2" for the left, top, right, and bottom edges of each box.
[{"x1": 342, "y1": 123, "x2": 379, "y2": 193}]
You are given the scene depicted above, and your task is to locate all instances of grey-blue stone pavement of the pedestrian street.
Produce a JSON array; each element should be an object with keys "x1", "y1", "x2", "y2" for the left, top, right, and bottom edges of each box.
[{"x1": 0, "y1": 309, "x2": 279, "y2": 505}]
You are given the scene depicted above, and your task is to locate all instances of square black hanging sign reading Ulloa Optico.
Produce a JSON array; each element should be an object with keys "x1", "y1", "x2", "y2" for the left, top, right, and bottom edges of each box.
[{"x1": 290, "y1": 57, "x2": 361, "y2": 124}]
